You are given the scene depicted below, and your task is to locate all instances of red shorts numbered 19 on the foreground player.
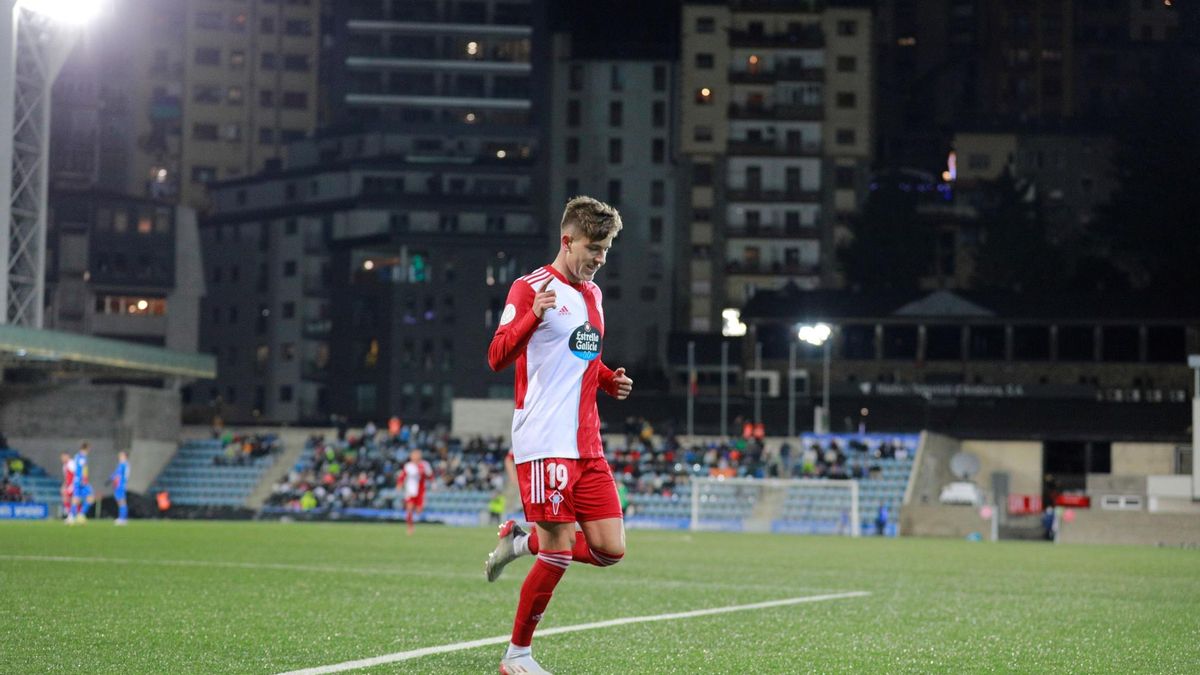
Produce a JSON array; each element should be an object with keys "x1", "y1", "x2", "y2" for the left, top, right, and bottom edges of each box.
[{"x1": 517, "y1": 458, "x2": 622, "y2": 522}]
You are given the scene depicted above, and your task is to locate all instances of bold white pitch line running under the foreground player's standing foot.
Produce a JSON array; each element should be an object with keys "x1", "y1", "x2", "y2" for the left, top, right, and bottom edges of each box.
[{"x1": 281, "y1": 591, "x2": 871, "y2": 675}]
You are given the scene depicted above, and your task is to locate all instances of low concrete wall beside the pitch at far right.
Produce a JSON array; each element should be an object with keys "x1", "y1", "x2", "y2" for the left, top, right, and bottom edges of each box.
[{"x1": 1058, "y1": 509, "x2": 1200, "y2": 546}]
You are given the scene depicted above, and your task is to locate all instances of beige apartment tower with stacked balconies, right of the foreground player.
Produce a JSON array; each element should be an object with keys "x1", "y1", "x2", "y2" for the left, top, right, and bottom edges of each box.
[{"x1": 680, "y1": 0, "x2": 875, "y2": 331}]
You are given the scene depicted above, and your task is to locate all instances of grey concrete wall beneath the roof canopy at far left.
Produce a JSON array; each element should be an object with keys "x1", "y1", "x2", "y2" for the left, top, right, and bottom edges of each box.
[{"x1": 0, "y1": 383, "x2": 180, "y2": 487}]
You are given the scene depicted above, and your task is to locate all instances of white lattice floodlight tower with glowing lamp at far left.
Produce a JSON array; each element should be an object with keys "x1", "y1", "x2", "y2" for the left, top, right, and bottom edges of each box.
[{"x1": 0, "y1": 0, "x2": 102, "y2": 328}]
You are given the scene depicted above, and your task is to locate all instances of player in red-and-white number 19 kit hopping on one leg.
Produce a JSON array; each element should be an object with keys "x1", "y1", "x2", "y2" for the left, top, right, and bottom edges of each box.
[{"x1": 485, "y1": 197, "x2": 634, "y2": 675}]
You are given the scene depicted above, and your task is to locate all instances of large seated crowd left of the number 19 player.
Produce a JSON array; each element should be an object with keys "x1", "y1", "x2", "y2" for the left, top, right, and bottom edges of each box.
[{"x1": 266, "y1": 424, "x2": 508, "y2": 510}]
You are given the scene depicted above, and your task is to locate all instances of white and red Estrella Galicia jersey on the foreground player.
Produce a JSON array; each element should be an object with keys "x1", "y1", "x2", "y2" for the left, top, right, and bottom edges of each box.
[{"x1": 487, "y1": 265, "x2": 617, "y2": 464}]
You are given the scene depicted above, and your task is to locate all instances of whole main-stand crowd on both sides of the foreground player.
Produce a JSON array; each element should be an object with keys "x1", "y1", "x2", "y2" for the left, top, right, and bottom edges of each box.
[{"x1": 266, "y1": 418, "x2": 907, "y2": 510}]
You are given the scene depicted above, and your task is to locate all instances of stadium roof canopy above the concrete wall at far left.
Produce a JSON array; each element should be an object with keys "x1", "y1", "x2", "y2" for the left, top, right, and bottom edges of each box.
[{"x1": 0, "y1": 324, "x2": 217, "y2": 380}]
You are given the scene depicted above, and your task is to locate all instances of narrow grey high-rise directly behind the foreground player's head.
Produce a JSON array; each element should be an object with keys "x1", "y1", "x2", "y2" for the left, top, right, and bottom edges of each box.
[{"x1": 546, "y1": 34, "x2": 679, "y2": 368}]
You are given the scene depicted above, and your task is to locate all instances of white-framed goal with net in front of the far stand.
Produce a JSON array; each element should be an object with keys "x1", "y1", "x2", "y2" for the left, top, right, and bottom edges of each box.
[{"x1": 689, "y1": 478, "x2": 862, "y2": 537}]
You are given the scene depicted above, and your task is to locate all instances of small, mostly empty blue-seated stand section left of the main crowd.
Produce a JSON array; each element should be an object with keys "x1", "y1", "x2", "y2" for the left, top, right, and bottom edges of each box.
[{"x1": 150, "y1": 435, "x2": 281, "y2": 507}]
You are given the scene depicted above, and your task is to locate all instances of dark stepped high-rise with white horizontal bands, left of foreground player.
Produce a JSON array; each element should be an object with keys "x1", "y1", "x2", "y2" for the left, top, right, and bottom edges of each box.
[{"x1": 202, "y1": 0, "x2": 542, "y2": 423}]
